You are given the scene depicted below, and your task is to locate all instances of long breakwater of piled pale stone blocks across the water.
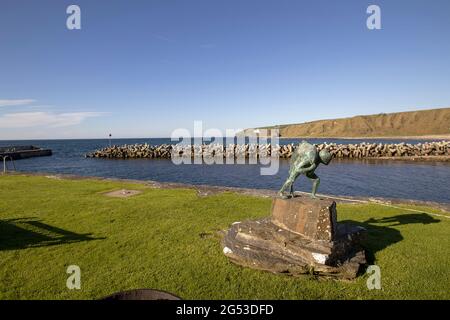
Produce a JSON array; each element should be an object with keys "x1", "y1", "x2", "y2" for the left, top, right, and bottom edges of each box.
[{"x1": 86, "y1": 141, "x2": 450, "y2": 159}]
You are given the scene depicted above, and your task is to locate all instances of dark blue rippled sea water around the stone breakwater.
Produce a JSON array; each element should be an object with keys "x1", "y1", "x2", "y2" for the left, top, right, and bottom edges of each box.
[{"x1": 0, "y1": 138, "x2": 450, "y2": 203}]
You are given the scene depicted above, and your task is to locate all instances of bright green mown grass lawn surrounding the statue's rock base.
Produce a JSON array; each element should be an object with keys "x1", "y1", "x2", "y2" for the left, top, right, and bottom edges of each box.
[{"x1": 0, "y1": 175, "x2": 450, "y2": 299}]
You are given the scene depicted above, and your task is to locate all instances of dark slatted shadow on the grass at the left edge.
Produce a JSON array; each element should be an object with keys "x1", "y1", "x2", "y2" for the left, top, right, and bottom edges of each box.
[{"x1": 0, "y1": 218, "x2": 105, "y2": 251}]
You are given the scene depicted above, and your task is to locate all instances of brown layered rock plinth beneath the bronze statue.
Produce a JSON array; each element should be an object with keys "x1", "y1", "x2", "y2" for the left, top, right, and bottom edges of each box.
[{"x1": 222, "y1": 197, "x2": 366, "y2": 279}]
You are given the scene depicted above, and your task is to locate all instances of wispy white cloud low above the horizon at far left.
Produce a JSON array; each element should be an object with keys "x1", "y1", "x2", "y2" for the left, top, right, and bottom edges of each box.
[{"x1": 0, "y1": 112, "x2": 105, "y2": 128}]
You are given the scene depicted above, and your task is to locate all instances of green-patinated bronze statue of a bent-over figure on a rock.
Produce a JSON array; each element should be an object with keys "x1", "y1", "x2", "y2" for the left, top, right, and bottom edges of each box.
[{"x1": 278, "y1": 141, "x2": 332, "y2": 199}]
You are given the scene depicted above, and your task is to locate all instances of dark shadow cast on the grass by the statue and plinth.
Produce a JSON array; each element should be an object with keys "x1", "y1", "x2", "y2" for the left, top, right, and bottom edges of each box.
[{"x1": 342, "y1": 213, "x2": 440, "y2": 264}]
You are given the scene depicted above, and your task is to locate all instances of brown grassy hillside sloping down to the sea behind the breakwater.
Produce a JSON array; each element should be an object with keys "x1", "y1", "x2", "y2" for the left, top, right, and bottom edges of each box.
[{"x1": 244, "y1": 108, "x2": 450, "y2": 138}]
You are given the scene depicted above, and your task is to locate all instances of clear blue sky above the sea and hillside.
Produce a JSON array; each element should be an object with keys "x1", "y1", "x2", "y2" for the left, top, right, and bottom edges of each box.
[{"x1": 0, "y1": 0, "x2": 450, "y2": 140}]
